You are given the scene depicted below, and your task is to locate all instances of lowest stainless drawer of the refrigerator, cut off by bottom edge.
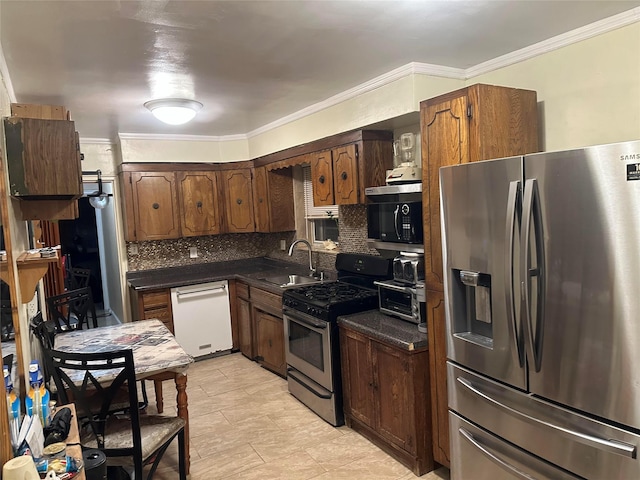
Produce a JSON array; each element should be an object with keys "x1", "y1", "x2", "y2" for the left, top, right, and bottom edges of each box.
[{"x1": 449, "y1": 411, "x2": 580, "y2": 480}]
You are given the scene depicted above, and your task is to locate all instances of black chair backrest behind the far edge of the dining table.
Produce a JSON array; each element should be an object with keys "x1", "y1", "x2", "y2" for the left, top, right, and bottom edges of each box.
[{"x1": 47, "y1": 287, "x2": 98, "y2": 332}]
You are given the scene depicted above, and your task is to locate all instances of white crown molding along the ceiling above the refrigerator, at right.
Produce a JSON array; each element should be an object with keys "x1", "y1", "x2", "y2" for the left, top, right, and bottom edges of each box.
[{"x1": 465, "y1": 7, "x2": 640, "y2": 80}]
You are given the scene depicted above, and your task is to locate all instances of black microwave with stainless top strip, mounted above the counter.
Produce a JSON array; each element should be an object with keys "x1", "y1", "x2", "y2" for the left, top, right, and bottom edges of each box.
[{"x1": 365, "y1": 183, "x2": 424, "y2": 246}]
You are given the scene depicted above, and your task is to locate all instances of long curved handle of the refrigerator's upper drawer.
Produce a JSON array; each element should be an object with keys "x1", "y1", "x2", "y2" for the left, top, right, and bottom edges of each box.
[{"x1": 456, "y1": 377, "x2": 637, "y2": 458}]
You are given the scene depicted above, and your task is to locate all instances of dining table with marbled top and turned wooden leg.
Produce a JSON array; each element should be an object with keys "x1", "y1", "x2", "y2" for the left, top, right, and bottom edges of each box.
[{"x1": 55, "y1": 320, "x2": 193, "y2": 474}]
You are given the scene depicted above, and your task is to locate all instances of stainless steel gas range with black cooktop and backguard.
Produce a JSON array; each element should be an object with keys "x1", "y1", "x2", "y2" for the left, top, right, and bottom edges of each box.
[{"x1": 282, "y1": 254, "x2": 393, "y2": 426}]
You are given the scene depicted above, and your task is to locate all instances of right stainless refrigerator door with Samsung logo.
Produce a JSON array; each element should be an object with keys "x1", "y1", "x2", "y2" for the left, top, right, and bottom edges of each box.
[{"x1": 521, "y1": 142, "x2": 640, "y2": 430}]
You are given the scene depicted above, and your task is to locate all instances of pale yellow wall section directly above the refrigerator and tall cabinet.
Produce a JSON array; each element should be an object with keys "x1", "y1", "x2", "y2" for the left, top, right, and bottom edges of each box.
[{"x1": 467, "y1": 23, "x2": 640, "y2": 151}]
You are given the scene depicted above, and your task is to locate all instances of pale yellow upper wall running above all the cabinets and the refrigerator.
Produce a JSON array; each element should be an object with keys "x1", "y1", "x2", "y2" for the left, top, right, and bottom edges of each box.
[{"x1": 107, "y1": 23, "x2": 640, "y2": 168}]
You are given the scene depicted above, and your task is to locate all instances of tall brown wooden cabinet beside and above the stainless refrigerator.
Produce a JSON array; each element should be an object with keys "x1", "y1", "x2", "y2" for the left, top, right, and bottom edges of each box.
[{"x1": 420, "y1": 84, "x2": 539, "y2": 467}]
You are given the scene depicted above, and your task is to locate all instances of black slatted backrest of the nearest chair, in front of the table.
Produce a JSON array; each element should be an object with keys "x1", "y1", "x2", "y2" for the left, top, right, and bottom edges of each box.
[{"x1": 45, "y1": 349, "x2": 142, "y2": 460}]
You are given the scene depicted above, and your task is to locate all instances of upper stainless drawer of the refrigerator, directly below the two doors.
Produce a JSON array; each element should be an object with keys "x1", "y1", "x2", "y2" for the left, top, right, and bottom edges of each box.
[{"x1": 447, "y1": 362, "x2": 640, "y2": 480}]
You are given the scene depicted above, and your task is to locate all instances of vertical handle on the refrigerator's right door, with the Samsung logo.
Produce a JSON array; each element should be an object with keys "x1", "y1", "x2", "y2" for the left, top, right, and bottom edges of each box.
[{"x1": 520, "y1": 179, "x2": 545, "y2": 372}]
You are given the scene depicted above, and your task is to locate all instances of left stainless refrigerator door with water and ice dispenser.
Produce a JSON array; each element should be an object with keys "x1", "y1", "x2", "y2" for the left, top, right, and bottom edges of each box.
[{"x1": 440, "y1": 157, "x2": 526, "y2": 389}]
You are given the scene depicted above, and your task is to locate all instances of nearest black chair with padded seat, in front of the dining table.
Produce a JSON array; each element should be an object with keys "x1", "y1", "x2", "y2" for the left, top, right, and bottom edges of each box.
[{"x1": 46, "y1": 350, "x2": 187, "y2": 480}]
